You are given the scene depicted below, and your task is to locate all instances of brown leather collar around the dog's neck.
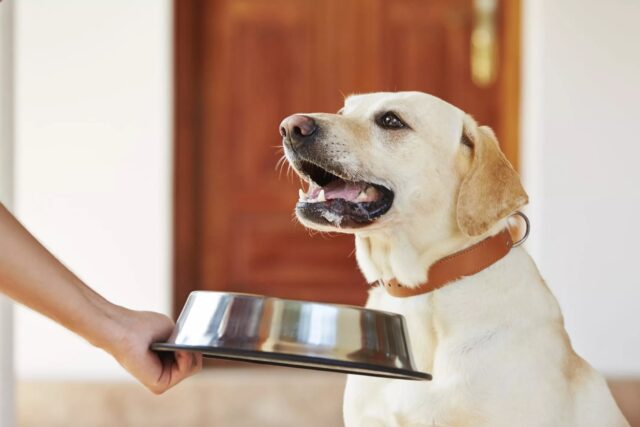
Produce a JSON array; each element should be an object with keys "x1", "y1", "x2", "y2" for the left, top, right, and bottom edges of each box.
[{"x1": 378, "y1": 228, "x2": 513, "y2": 298}]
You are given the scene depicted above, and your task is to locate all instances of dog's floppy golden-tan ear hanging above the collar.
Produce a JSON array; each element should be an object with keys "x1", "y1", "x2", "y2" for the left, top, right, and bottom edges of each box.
[{"x1": 456, "y1": 126, "x2": 528, "y2": 236}]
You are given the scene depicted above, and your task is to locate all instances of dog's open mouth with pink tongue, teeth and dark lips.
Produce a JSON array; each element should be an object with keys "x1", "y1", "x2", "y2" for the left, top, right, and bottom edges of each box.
[{"x1": 296, "y1": 160, "x2": 394, "y2": 228}]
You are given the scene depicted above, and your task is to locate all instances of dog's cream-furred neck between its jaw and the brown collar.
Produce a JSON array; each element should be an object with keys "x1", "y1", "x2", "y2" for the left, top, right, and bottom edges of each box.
[{"x1": 356, "y1": 221, "x2": 506, "y2": 287}]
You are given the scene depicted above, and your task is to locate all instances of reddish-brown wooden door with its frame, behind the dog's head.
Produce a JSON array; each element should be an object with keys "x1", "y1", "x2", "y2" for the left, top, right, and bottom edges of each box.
[{"x1": 175, "y1": 0, "x2": 519, "y2": 312}]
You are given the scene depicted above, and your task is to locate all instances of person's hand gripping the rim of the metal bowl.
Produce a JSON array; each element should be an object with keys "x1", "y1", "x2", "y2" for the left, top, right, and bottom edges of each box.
[{"x1": 105, "y1": 307, "x2": 202, "y2": 394}]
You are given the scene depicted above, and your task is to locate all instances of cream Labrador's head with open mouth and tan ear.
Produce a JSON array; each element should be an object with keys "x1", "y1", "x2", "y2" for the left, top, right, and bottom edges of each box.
[{"x1": 280, "y1": 92, "x2": 527, "y2": 236}]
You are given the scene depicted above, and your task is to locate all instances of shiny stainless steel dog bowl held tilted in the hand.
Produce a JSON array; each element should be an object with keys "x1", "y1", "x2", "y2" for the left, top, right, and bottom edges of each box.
[{"x1": 151, "y1": 291, "x2": 431, "y2": 380}]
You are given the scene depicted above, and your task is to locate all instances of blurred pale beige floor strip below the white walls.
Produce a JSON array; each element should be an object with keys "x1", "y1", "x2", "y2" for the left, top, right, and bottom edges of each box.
[{"x1": 18, "y1": 367, "x2": 640, "y2": 427}]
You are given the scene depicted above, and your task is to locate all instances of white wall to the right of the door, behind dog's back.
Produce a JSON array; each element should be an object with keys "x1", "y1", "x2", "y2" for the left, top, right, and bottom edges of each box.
[{"x1": 523, "y1": 0, "x2": 640, "y2": 375}]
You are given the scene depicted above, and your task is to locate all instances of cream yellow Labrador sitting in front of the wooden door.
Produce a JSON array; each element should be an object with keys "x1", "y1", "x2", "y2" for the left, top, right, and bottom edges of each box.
[{"x1": 280, "y1": 92, "x2": 629, "y2": 427}]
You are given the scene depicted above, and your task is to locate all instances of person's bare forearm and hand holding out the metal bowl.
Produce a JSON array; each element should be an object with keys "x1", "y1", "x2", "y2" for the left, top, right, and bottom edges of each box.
[{"x1": 0, "y1": 204, "x2": 202, "y2": 393}]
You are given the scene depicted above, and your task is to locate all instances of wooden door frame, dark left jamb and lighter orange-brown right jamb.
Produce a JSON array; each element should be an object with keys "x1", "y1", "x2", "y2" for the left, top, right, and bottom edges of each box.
[{"x1": 172, "y1": 0, "x2": 521, "y2": 317}]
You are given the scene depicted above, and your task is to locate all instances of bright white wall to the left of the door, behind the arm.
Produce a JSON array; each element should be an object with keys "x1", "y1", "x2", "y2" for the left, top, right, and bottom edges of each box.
[{"x1": 15, "y1": 0, "x2": 171, "y2": 379}]
